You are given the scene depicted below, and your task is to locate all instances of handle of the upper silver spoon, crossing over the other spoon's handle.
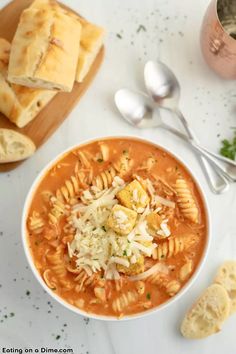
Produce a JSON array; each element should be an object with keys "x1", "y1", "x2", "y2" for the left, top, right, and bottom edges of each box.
[{"x1": 173, "y1": 109, "x2": 229, "y2": 194}]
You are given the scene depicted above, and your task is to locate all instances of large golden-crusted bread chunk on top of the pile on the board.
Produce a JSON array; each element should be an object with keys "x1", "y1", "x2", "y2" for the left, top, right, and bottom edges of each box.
[{"x1": 8, "y1": 6, "x2": 81, "y2": 92}]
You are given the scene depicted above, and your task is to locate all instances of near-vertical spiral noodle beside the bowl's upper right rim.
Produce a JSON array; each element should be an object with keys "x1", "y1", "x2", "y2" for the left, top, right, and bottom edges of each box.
[{"x1": 175, "y1": 178, "x2": 199, "y2": 223}]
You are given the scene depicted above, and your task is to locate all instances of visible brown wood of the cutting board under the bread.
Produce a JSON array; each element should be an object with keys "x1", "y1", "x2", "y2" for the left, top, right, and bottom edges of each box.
[{"x1": 0, "y1": 0, "x2": 104, "y2": 172}]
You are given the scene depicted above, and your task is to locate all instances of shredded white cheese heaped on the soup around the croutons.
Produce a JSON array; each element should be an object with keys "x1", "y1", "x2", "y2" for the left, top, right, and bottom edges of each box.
[{"x1": 67, "y1": 176, "x2": 170, "y2": 279}]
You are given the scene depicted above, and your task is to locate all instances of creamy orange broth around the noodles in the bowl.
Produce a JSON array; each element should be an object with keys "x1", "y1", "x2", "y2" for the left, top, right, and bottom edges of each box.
[{"x1": 28, "y1": 138, "x2": 207, "y2": 316}]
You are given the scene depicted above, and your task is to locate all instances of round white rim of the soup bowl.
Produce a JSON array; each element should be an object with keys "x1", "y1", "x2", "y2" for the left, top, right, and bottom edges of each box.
[{"x1": 21, "y1": 136, "x2": 211, "y2": 321}]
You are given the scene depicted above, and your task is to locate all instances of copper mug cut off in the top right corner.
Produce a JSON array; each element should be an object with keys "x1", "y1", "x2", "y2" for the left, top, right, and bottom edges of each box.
[{"x1": 201, "y1": 0, "x2": 236, "y2": 79}]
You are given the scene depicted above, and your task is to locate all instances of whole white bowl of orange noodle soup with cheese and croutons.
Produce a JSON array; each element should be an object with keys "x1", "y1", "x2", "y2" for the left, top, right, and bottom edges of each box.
[{"x1": 22, "y1": 137, "x2": 210, "y2": 320}]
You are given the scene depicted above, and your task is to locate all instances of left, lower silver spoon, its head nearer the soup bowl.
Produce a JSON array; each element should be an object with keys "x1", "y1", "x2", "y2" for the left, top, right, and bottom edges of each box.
[{"x1": 115, "y1": 89, "x2": 232, "y2": 193}]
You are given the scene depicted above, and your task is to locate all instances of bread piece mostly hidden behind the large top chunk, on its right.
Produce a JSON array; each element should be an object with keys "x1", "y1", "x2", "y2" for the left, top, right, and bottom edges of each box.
[{"x1": 31, "y1": 0, "x2": 105, "y2": 82}]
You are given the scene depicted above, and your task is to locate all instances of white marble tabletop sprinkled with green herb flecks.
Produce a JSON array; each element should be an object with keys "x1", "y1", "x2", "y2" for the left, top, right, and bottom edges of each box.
[{"x1": 0, "y1": 0, "x2": 236, "y2": 354}]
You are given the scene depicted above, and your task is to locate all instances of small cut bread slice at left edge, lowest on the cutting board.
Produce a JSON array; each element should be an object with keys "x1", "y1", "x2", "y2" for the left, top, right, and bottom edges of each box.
[{"x1": 0, "y1": 128, "x2": 35, "y2": 163}]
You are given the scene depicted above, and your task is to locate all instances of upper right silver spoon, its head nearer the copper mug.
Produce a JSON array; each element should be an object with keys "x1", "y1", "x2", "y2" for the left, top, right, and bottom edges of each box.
[{"x1": 144, "y1": 61, "x2": 236, "y2": 187}]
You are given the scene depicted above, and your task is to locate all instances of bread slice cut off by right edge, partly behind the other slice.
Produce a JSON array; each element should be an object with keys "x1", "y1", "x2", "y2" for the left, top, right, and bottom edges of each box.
[{"x1": 214, "y1": 261, "x2": 236, "y2": 314}]
